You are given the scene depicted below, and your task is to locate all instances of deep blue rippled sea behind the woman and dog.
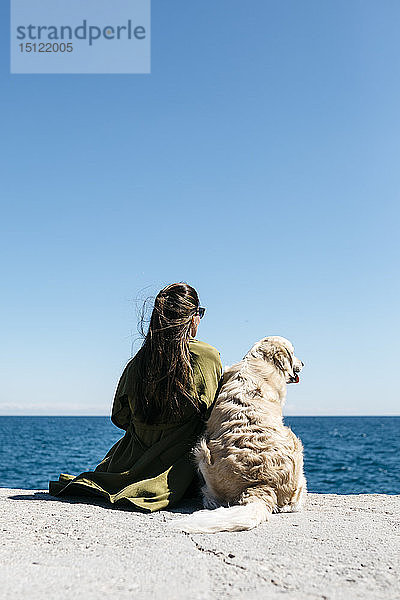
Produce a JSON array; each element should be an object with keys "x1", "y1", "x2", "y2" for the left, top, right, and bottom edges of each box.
[{"x1": 0, "y1": 417, "x2": 400, "y2": 494}]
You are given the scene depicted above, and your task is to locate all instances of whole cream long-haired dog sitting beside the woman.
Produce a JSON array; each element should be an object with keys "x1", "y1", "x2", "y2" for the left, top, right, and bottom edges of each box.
[{"x1": 172, "y1": 336, "x2": 307, "y2": 533}]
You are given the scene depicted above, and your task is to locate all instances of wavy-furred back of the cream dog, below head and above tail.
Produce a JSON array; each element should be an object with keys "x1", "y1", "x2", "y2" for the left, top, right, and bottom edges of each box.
[{"x1": 194, "y1": 364, "x2": 303, "y2": 511}]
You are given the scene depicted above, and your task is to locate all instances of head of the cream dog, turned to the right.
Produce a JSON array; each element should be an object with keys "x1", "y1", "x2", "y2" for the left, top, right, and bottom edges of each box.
[{"x1": 248, "y1": 335, "x2": 304, "y2": 383}]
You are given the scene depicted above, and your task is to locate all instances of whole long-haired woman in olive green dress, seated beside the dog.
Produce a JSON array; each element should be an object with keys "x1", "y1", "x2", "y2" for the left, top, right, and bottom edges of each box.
[{"x1": 49, "y1": 283, "x2": 222, "y2": 512}]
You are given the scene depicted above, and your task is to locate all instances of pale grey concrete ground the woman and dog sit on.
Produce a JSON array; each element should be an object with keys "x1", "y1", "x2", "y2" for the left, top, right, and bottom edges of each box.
[{"x1": 0, "y1": 488, "x2": 400, "y2": 600}]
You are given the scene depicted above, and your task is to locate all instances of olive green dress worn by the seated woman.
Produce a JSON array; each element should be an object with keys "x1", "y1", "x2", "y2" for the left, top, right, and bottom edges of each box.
[{"x1": 49, "y1": 338, "x2": 222, "y2": 512}]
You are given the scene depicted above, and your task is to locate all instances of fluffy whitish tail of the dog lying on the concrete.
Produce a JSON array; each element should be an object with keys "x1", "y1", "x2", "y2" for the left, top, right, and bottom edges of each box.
[{"x1": 171, "y1": 499, "x2": 271, "y2": 533}]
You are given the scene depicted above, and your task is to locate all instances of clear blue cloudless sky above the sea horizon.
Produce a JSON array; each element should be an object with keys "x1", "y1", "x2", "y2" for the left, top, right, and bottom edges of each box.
[{"x1": 0, "y1": 0, "x2": 400, "y2": 415}]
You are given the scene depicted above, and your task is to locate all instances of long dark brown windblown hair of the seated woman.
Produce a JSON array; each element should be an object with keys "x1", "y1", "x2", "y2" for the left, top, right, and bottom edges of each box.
[{"x1": 133, "y1": 283, "x2": 199, "y2": 423}]
